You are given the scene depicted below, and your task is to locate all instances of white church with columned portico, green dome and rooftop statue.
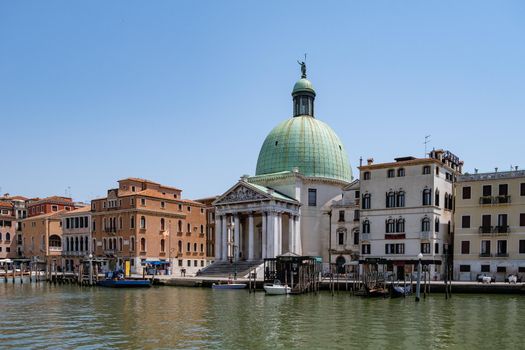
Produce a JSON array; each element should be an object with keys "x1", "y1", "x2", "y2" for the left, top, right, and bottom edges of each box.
[{"x1": 213, "y1": 63, "x2": 352, "y2": 262}]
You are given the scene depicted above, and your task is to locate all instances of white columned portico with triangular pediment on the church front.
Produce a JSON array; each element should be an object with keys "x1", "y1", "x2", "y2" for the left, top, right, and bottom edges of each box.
[{"x1": 214, "y1": 180, "x2": 301, "y2": 261}]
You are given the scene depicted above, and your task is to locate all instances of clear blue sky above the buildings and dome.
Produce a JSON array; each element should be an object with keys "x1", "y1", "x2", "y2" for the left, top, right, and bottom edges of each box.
[{"x1": 0, "y1": 0, "x2": 525, "y2": 200}]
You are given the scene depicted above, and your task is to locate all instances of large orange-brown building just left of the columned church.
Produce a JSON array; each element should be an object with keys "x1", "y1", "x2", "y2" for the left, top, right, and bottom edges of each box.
[{"x1": 91, "y1": 178, "x2": 206, "y2": 274}]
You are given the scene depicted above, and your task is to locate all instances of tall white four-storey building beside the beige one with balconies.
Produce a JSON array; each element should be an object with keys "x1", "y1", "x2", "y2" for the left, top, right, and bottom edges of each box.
[{"x1": 359, "y1": 150, "x2": 463, "y2": 279}]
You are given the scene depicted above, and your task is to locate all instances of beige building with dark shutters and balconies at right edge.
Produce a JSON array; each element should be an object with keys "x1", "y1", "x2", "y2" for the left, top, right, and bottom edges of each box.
[{"x1": 454, "y1": 170, "x2": 525, "y2": 281}]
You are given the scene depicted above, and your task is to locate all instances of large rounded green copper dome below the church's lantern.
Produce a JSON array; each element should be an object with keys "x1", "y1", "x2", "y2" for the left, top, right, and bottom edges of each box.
[{"x1": 256, "y1": 116, "x2": 352, "y2": 182}]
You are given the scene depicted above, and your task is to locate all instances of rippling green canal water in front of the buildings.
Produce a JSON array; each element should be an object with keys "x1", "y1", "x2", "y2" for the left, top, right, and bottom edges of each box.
[{"x1": 0, "y1": 282, "x2": 525, "y2": 349}]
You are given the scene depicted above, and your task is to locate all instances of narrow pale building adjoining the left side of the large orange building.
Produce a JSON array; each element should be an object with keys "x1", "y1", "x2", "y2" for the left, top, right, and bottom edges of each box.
[{"x1": 62, "y1": 206, "x2": 93, "y2": 272}]
